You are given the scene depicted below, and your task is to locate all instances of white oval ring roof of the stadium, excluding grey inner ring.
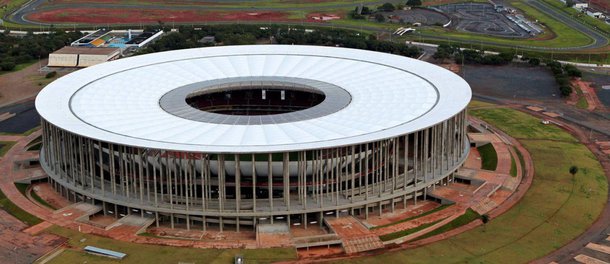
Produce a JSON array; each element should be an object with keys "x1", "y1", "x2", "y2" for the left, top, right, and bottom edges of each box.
[{"x1": 36, "y1": 45, "x2": 471, "y2": 153}]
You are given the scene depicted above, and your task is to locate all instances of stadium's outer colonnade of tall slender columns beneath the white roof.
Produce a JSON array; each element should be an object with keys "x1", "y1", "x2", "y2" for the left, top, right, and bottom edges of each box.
[{"x1": 41, "y1": 111, "x2": 468, "y2": 230}]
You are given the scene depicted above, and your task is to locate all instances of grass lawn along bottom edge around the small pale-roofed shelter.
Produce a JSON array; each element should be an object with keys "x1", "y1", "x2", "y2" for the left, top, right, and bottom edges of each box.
[{"x1": 47, "y1": 226, "x2": 296, "y2": 264}]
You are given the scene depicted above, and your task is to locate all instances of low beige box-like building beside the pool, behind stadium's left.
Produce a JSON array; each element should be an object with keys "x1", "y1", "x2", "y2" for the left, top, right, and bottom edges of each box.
[{"x1": 48, "y1": 46, "x2": 121, "y2": 67}]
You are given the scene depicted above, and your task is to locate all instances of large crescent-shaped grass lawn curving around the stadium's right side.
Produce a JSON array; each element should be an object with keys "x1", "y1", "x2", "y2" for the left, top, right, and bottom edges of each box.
[{"x1": 340, "y1": 104, "x2": 608, "y2": 263}]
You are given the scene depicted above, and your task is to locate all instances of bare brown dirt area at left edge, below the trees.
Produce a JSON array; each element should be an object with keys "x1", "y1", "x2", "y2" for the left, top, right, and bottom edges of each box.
[{"x1": 0, "y1": 59, "x2": 47, "y2": 107}]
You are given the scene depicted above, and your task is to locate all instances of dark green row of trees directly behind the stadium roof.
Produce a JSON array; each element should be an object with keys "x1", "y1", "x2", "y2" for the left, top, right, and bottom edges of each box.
[{"x1": 139, "y1": 25, "x2": 421, "y2": 57}]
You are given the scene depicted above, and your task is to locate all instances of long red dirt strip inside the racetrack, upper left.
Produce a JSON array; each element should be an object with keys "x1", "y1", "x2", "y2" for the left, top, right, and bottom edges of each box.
[{"x1": 28, "y1": 8, "x2": 300, "y2": 24}]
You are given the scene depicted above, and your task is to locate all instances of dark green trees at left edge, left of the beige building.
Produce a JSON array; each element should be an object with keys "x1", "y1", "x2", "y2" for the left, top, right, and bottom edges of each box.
[{"x1": 0, "y1": 30, "x2": 83, "y2": 71}]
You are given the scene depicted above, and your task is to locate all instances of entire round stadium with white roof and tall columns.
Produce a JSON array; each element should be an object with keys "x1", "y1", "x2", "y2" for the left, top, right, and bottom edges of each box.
[{"x1": 36, "y1": 45, "x2": 471, "y2": 231}]
